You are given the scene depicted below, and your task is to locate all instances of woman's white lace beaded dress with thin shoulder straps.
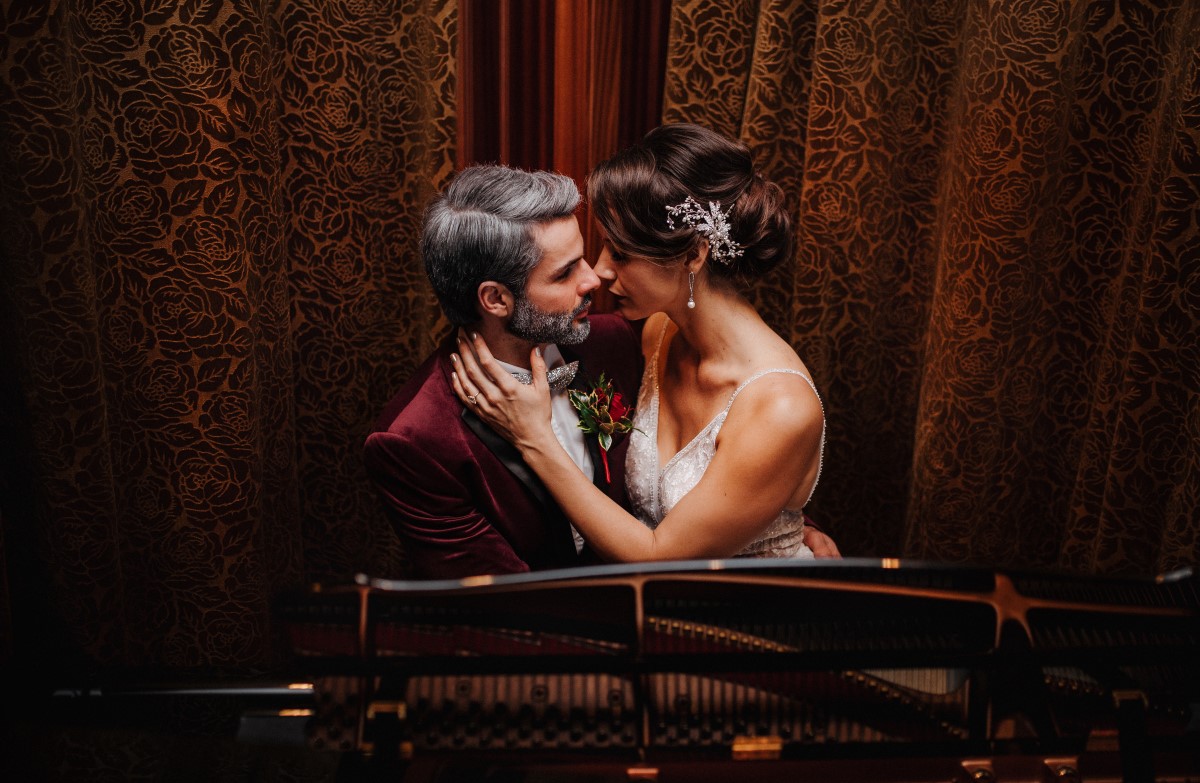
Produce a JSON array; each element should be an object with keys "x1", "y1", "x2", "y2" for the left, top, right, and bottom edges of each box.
[{"x1": 625, "y1": 325, "x2": 824, "y2": 558}]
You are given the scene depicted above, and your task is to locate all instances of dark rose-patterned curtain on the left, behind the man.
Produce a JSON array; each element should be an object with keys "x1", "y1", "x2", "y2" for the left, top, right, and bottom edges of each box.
[{"x1": 0, "y1": 0, "x2": 456, "y2": 667}]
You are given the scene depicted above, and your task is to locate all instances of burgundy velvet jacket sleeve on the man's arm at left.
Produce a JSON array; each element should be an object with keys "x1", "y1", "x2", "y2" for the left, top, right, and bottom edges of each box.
[{"x1": 364, "y1": 432, "x2": 529, "y2": 579}]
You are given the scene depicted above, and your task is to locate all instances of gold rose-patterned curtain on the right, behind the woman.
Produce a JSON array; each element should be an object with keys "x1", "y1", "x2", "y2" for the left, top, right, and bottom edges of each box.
[{"x1": 665, "y1": 0, "x2": 1200, "y2": 574}]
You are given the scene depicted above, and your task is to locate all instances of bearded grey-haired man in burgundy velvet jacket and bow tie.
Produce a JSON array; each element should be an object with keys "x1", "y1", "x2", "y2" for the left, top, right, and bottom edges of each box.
[{"x1": 365, "y1": 166, "x2": 642, "y2": 579}]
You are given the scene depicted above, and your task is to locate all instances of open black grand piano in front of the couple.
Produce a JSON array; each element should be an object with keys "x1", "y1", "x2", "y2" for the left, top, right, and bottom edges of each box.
[{"x1": 46, "y1": 560, "x2": 1200, "y2": 783}]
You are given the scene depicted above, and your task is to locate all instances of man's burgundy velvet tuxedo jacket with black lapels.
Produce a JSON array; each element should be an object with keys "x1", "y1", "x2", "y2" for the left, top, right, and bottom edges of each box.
[{"x1": 364, "y1": 315, "x2": 642, "y2": 579}]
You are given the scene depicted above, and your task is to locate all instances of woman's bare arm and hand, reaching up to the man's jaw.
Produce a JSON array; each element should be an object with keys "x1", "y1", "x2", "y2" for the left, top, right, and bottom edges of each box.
[{"x1": 454, "y1": 337, "x2": 822, "y2": 561}]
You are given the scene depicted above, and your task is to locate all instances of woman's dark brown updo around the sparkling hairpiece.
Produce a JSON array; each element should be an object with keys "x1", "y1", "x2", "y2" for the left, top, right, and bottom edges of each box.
[{"x1": 588, "y1": 124, "x2": 792, "y2": 277}]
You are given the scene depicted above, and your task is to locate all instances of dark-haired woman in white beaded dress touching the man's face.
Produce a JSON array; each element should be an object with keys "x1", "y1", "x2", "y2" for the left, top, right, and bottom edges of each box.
[{"x1": 452, "y1": 125, "x2": 836, "y2": 561}]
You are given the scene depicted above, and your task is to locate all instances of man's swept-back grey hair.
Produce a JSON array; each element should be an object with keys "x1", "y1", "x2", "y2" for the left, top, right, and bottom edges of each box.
[{"x1": 421, "y1": 166, "x2": 580, "y2": 327}]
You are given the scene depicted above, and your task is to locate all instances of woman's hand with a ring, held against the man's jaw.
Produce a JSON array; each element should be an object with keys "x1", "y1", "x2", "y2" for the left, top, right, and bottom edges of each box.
[{"x1": 450, "y1": 330, "x2": 554, "y2": 449}]
